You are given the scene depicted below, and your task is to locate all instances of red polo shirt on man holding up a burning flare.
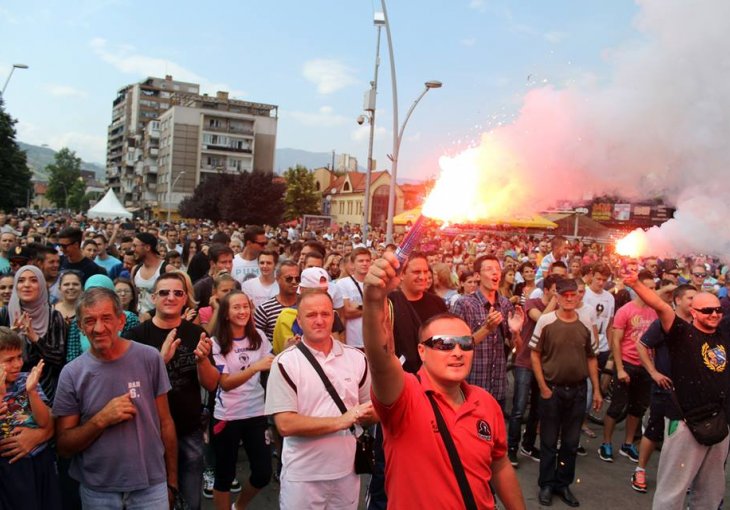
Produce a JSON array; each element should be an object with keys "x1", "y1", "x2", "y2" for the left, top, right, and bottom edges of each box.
[{"x1": 372, "y1": 368, "x2": 507, "y2": 510}]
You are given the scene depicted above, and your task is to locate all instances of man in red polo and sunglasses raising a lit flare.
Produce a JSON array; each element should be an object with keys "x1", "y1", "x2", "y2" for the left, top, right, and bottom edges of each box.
[{"x1": 363, "y1": 253, "x2": 525, "y2": 509}]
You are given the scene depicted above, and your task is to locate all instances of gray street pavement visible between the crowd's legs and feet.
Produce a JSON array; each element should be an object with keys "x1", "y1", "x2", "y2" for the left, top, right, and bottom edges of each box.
[{"x1": 203, "y1": 416, "x2": 720, "y2": 510}]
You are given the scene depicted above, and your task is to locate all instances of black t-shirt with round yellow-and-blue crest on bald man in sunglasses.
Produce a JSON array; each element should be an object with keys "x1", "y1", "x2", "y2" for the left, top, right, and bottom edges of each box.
[{"x1": 642, "y1": 316, "x2": 730, "y2": 419}]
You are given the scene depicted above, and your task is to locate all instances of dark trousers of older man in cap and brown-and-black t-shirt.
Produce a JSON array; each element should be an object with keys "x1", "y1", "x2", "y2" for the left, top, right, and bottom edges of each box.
[{"x1": 537, "y1": 381, "x2": 586, "y2": 490}]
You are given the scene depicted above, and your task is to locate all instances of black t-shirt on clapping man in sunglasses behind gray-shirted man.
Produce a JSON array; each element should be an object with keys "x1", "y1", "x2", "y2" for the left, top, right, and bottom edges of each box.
[{"x1": 129, "y1": 320, "x2": 204, "y2": 436}]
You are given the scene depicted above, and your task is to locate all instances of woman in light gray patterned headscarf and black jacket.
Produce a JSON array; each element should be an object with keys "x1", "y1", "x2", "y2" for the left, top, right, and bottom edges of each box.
[{"x1": 8, "y1": 266, "x2": 66, "y2": 402}]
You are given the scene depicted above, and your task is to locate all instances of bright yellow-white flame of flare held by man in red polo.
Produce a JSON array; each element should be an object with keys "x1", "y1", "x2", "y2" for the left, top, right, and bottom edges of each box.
[{"x1": 423, "y1": 134, "x2": 524, "y2": 223}]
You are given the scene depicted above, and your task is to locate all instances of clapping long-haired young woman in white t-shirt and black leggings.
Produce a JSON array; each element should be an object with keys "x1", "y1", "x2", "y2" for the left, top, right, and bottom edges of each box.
[{"x1": 212, "y1": 290, "x2": 274, "y2": 510}]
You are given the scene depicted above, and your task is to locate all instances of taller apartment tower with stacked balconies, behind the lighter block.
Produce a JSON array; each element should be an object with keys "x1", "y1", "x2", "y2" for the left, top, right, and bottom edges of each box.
[{"x1": 106, "y1": 76, "x2": 200, "y2": 207}]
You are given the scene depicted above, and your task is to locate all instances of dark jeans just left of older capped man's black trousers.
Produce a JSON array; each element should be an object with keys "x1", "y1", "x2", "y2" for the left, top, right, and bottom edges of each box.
[{"x1": 507, "y1": 367, "x2": 540, "y2": 450}]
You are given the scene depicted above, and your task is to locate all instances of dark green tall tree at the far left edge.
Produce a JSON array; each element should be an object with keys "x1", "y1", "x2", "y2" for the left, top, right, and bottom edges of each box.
[{"x1": 0, "y1": 96, "x2": 33, "y2": 211}]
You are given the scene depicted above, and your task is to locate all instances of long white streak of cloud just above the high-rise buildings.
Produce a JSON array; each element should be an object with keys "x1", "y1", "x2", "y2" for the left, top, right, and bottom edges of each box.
[{"x1": 89, "y1": 37, "x2": 247, "y2": 97}]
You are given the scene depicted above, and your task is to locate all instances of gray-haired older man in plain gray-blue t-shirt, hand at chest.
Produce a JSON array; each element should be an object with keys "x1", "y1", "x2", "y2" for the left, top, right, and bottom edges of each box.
[{"x1": 53, "y1": 287, "x2": 177, "y2": 510}]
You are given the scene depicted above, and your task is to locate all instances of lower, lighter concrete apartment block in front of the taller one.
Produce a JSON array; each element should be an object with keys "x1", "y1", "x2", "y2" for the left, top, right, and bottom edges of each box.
[{"x1": 156, "y1": 92, "x2": 278, "y2": 216}]
